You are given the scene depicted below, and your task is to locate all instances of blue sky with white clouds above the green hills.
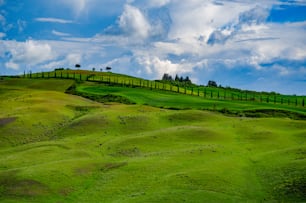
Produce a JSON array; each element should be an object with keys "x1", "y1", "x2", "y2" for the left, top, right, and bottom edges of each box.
[{"x1": 0, "y1": 0, "x2": 306, "y2": 95}]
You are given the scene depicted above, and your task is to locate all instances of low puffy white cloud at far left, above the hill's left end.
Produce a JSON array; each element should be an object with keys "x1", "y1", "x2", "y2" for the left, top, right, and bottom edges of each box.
[{"x1": 5, "y1": 40, "x2": 56, "y2": 69}]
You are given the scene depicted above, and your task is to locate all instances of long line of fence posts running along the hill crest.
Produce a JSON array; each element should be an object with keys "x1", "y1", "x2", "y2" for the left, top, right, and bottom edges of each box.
[{"x1": 24, "y1": 71, "x2": 305, "y2": 107}]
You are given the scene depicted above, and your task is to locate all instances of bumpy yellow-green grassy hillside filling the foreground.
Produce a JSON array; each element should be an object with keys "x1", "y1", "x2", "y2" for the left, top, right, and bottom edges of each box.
[{"x1": 0, "y1": 79, "x2": 306, "y2": 202}]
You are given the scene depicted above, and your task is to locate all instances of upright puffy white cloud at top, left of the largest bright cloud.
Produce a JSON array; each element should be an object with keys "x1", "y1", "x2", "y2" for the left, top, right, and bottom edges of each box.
[{"x1": 118, "y1": 5, "x2": 151, "y2": 40}]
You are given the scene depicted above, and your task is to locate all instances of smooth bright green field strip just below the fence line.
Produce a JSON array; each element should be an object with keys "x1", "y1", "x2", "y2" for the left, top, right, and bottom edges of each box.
[{"x1": 76, "y1": 83, "x2": 306, "y2": 115}]
